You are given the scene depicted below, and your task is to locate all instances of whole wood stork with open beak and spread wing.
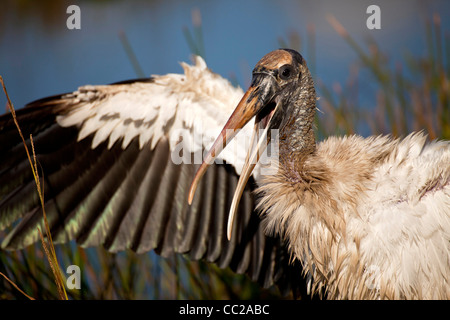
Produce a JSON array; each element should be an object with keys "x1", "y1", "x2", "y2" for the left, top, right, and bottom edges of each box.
[{"x1": 0, "y1": 49, "x2": 450, "y2": 299}]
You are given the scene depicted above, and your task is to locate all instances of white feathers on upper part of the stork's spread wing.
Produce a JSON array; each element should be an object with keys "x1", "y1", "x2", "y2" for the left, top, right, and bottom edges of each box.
[{"x1": 57, "y1": 56, "x2": 266, "y2": 175}]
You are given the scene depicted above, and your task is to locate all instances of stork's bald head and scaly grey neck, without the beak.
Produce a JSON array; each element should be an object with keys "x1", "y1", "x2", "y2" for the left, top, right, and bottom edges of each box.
[{"x1": 249, "y1": 49, "x2": 316, "y2": 158}]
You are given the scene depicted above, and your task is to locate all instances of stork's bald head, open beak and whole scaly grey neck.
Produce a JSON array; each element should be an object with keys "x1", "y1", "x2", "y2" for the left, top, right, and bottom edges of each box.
[{"x1": 189, "y1": 49, "x2": 316, "y2": 238}]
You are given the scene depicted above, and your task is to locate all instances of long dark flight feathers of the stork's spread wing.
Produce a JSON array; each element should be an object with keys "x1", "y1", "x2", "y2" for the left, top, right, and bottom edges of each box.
[{"x1": 0, "y1": 82, "x2": 310, "y2": 293}]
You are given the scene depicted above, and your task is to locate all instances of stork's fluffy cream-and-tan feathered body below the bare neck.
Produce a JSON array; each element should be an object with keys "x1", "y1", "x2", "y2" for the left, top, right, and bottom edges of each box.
[{"x1": 257, "y1": 134, "x2": 450, "y2": 299}]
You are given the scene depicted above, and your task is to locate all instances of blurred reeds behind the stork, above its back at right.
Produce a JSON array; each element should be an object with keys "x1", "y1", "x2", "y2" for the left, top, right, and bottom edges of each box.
[{"x1": 317, "y1": 14, "x2": 450, "y2": 139}]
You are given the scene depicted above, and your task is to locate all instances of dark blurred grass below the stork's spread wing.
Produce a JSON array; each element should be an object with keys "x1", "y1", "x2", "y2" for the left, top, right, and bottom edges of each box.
[{"x1": 0, "y1": 243, "x2": 279, "y2": 299}]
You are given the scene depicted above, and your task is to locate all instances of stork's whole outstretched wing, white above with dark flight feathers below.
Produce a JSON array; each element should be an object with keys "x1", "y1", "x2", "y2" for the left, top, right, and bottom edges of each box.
[{"x1": 0, "y1": 58, "x2": 304, "y2": 292}]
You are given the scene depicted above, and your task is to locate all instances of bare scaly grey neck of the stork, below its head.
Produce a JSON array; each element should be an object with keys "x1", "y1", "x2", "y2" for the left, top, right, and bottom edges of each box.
[{"x1": 280, "y1": 69, "x2": 316, "y2": 164}]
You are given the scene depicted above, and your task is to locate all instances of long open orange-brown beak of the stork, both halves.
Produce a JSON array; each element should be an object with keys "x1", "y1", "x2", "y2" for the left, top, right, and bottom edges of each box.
[{"x1": 188, "y1": 74, "x2": 277, "y2": 240}]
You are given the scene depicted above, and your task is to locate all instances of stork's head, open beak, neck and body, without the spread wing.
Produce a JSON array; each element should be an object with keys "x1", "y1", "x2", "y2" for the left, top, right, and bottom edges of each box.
[{"x1": 191, "y1": 49, "x2": 450, "y2": 299}]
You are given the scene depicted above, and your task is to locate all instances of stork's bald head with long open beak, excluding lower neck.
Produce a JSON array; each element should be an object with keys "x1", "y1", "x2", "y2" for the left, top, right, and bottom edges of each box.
[{"x1": 189, "y1": 49, "x2": 311, "y2": 239}]
